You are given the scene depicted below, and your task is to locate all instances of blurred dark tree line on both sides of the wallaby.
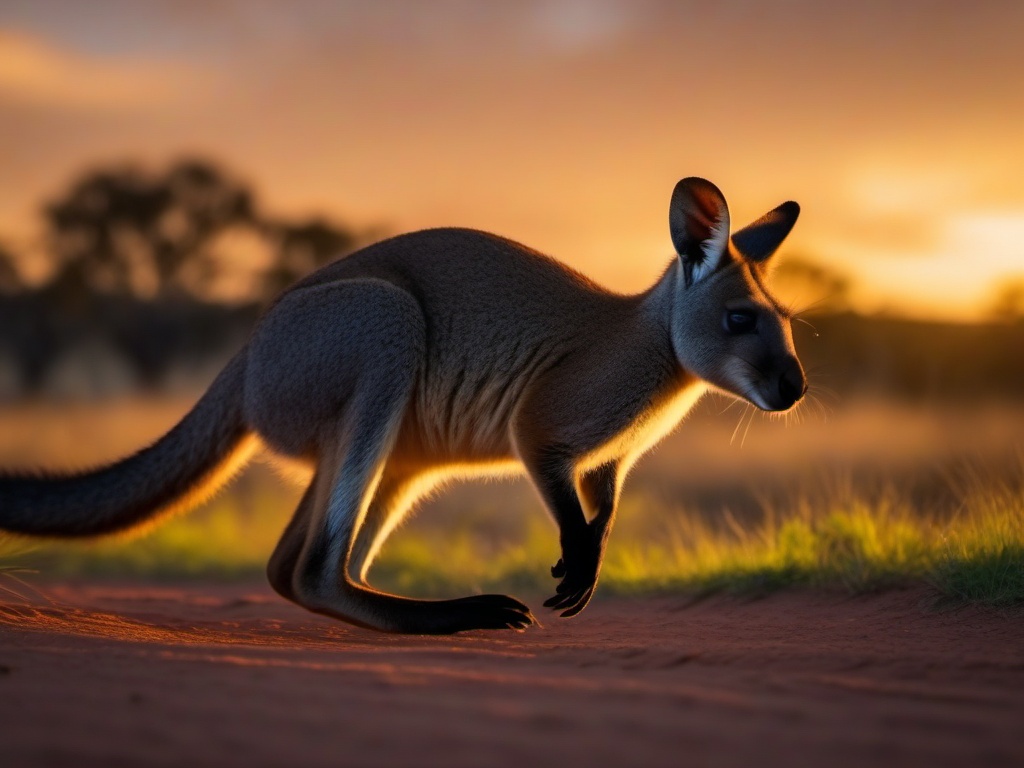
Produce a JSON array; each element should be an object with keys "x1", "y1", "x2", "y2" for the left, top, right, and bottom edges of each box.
[{"x1": 0, "y1": 159, "x2": 1024, "y2": 400}]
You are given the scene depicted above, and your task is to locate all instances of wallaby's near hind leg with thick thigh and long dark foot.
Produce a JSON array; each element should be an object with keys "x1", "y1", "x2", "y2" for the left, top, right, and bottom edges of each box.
[{"x1": 246, "y1": 280, "x2": 532, "y2": 634}]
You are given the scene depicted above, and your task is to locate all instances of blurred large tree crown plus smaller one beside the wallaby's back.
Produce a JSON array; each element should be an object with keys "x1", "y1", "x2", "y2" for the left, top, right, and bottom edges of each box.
[{"x1": 43, "y1": 159, "x2": 359, "y2": 306}]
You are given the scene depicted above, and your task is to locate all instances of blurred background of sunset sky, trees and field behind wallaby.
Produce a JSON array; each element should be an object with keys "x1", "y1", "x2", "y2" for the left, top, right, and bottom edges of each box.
[{"x1": 0, "y1": 0, "x2": 1024, "y2": 589}]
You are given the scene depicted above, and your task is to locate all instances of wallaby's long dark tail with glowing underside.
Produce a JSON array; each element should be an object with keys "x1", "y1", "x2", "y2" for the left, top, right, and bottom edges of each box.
[{"x1": 0, "y1": 352, "x2": 259, "y2": 538}]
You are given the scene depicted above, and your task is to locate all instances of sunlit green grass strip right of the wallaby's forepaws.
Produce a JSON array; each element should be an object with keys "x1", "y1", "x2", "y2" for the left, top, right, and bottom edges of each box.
[{"x1": 605, "y1": 499, "x2": 1024, "y2": 606}]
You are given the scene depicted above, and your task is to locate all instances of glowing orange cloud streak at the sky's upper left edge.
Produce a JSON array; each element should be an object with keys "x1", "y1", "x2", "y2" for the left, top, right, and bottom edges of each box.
[{"x1": 0, "y1": 29, "x2": 209, "y2": 110}]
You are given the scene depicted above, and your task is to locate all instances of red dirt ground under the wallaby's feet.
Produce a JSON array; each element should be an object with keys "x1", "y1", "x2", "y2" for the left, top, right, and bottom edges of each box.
[{"x1": 0, "y1": 585, "x2": 1024, "y2": 768}]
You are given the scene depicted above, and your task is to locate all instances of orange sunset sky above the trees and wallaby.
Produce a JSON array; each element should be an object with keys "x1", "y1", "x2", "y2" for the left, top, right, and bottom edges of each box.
[{"x1": 0, "y1": 0, "x2": 1024, "y2": 318}]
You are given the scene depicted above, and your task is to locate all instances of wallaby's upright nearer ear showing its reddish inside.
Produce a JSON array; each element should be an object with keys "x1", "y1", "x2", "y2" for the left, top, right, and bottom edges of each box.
[{"x1": 669, "y1": 176, "x2": 729, "y2": 287}]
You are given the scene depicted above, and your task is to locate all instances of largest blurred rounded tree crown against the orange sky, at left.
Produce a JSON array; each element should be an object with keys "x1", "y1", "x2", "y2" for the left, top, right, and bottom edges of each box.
[{"x1": 44, "y1": 160, "x2": 258, "y2": 298}]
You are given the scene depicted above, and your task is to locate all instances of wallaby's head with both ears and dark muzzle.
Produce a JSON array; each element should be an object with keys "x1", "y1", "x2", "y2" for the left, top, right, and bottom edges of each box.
[{"x1": 669, "y1": 178, "x2": 807, "y2": 411}]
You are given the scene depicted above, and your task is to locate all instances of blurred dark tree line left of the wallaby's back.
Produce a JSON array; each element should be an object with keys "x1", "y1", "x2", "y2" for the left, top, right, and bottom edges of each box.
[{"x1": 0, "y1": 159, "x2": 368, "y2": 396}]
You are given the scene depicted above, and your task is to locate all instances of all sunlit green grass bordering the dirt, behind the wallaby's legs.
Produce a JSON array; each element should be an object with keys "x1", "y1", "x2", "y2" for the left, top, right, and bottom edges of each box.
[{"x1": 3, "y1": 466, "x2": 1024, "y2": 607}]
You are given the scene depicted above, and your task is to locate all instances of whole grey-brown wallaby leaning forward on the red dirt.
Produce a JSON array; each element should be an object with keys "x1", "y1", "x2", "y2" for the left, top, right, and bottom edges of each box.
[{"x1": 0, "y1": 178, "x2": 806, "y2": 634}]
